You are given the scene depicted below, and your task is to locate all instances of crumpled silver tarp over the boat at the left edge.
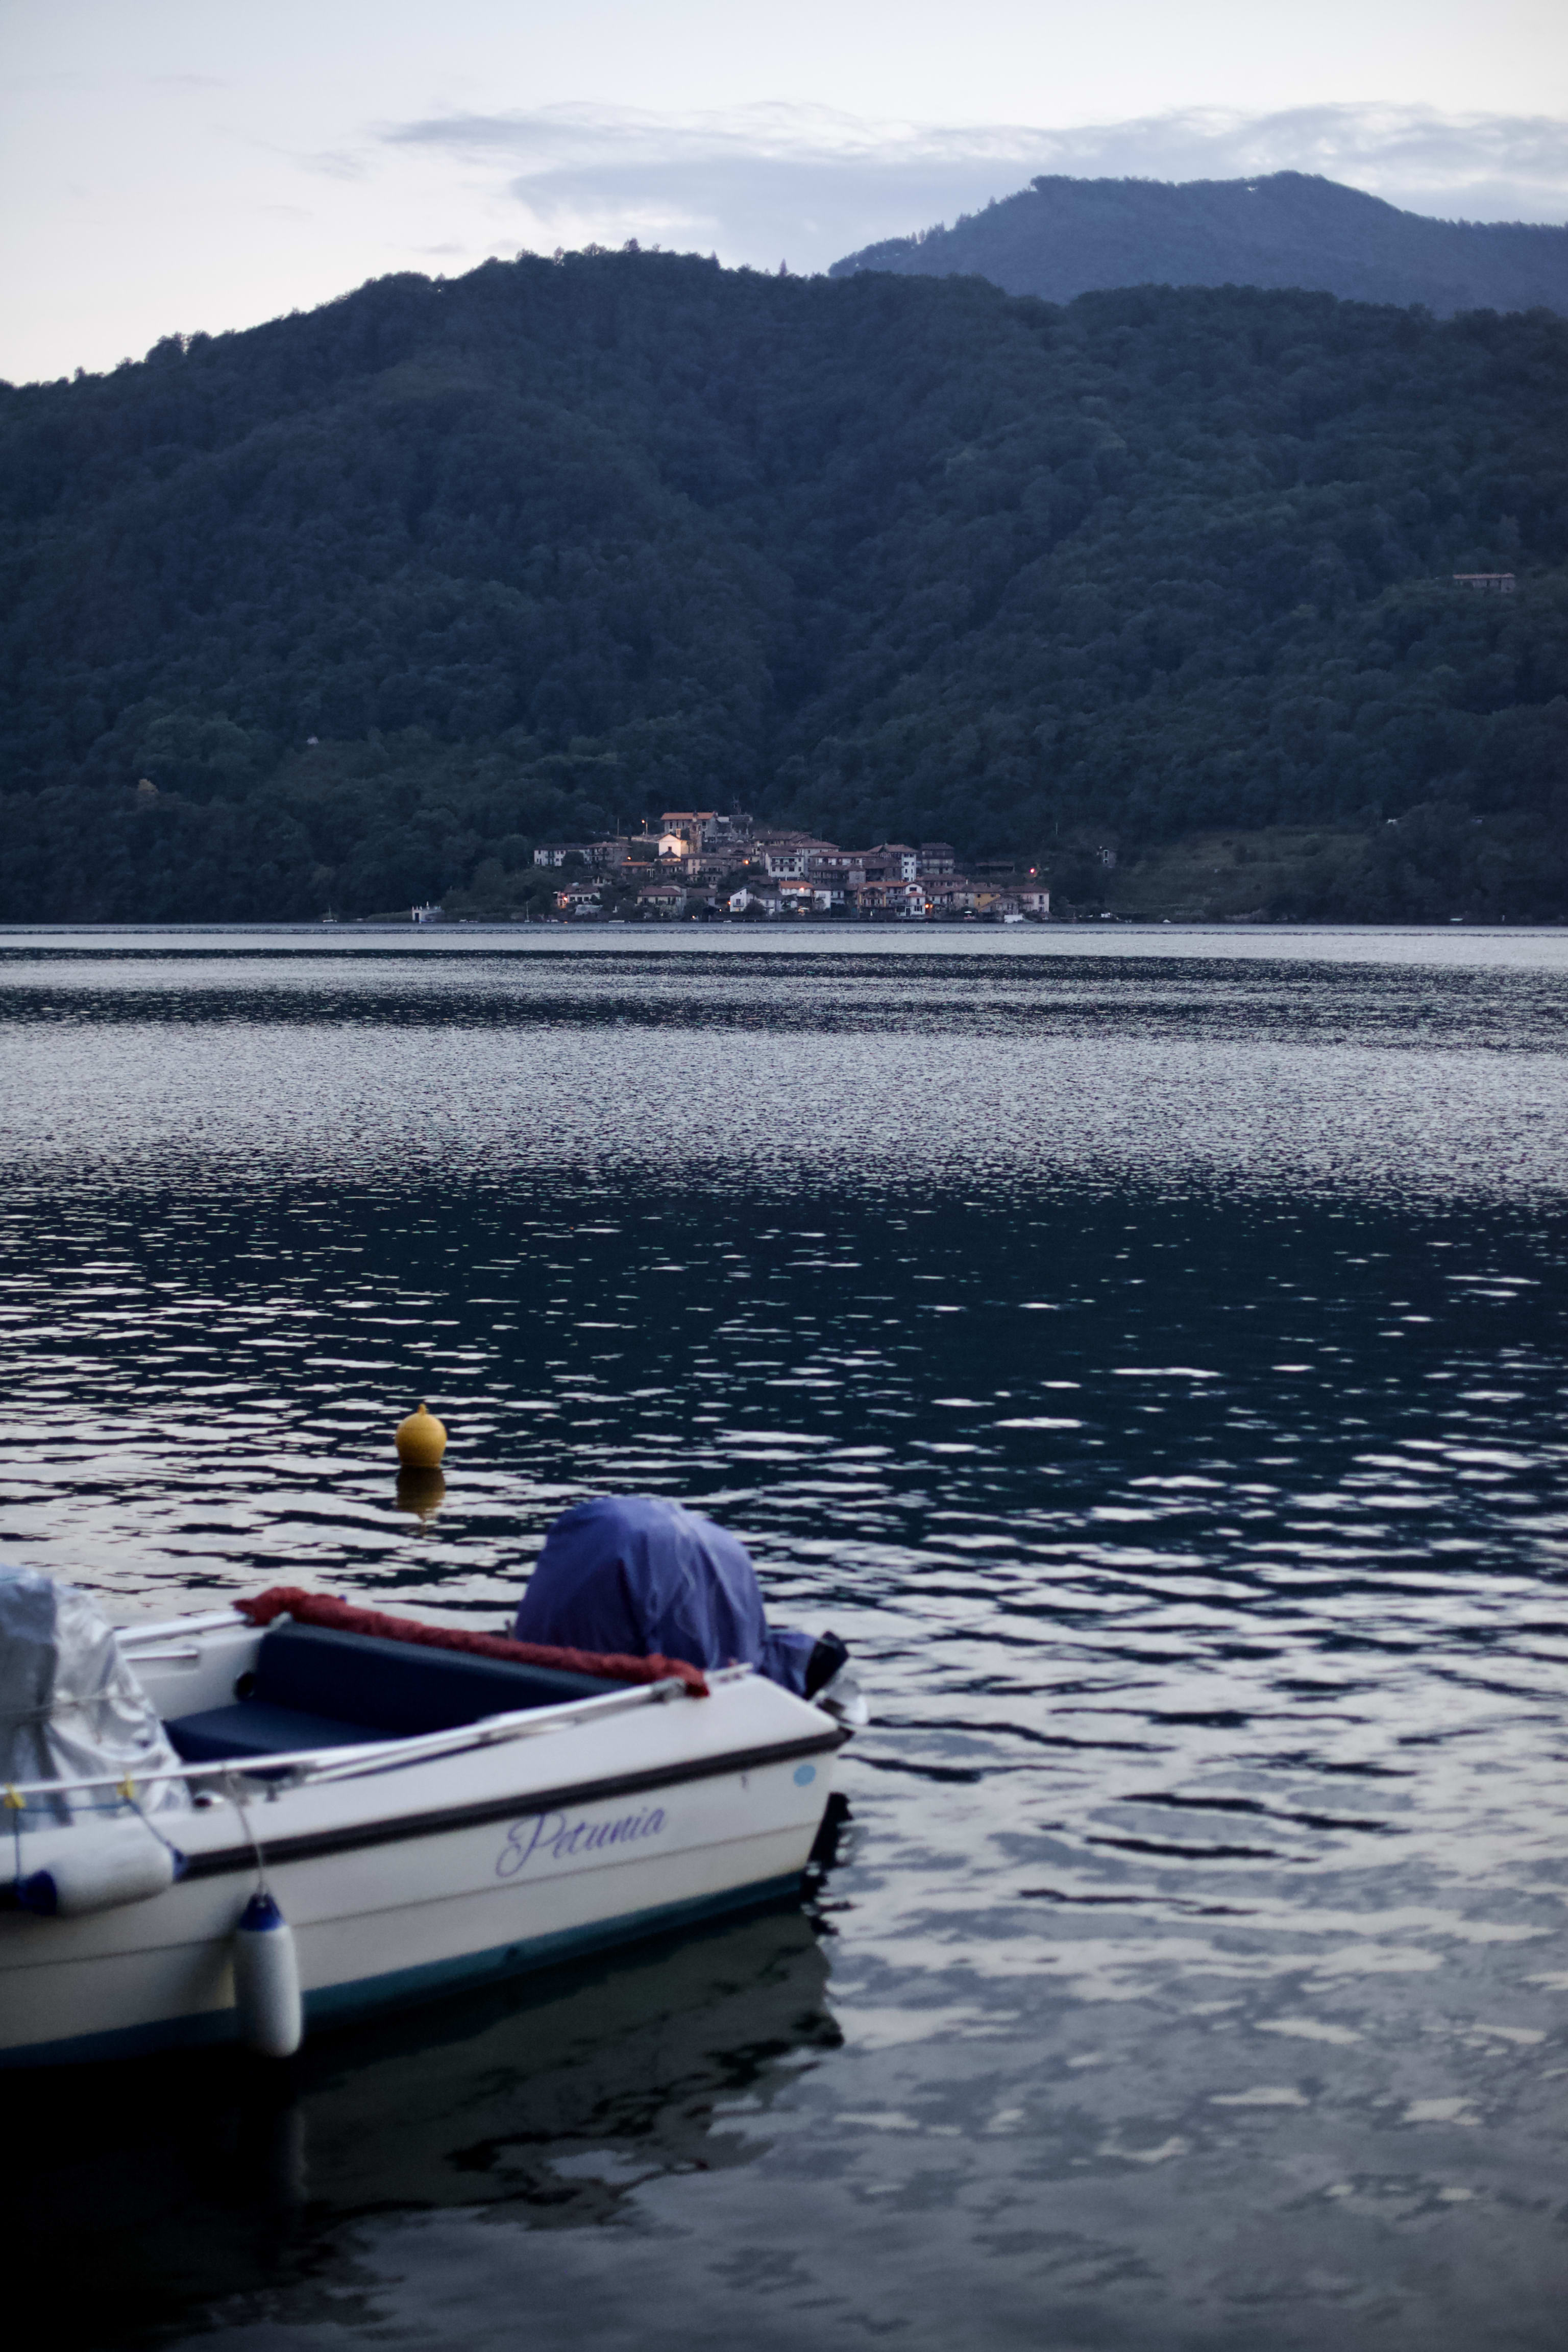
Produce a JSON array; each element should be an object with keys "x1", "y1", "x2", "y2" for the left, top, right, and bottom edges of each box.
[{"x1": 0, "y1": 1569, "x2": 190, "y2": 1825}]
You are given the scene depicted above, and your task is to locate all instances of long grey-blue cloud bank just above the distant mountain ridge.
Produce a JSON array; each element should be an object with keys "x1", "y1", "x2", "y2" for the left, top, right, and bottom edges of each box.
[{"x1": 379, "y1": 104, "x2": 1568, "y2": 271}]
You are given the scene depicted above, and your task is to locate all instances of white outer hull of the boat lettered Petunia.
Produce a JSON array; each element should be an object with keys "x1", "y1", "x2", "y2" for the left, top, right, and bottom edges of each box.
[{"x1": 0, "y1": 1646, "x2": 842, "y2": 2068}]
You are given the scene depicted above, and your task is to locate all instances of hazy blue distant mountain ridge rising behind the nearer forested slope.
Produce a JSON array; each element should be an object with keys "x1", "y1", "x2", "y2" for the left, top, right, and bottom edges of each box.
[{"x1": 827, "y1": 172, "x2": 1568, "y2": 318}]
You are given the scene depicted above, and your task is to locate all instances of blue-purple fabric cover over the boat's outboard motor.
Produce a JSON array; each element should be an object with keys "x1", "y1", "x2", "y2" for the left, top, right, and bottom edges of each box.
[{"x1": 512, "y1": 1493, "x2": 816, "y2": 1693}]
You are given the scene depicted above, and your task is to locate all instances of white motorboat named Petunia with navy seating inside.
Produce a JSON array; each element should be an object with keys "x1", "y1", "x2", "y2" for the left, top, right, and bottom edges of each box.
[{"x1": 0, "y1": 1609, "x2": 863, "y2": 2065}]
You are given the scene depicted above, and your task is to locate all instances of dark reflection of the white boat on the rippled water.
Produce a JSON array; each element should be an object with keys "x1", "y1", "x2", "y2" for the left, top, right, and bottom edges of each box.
[{"x1": 0, "y1": 1905, "x2": 842, "y2": 2345}]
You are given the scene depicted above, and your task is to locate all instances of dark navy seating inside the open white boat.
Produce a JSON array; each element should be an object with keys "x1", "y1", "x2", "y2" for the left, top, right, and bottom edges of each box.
[{"x1": 164, "y1": 1625, "x2": 623, "y2": 1764}]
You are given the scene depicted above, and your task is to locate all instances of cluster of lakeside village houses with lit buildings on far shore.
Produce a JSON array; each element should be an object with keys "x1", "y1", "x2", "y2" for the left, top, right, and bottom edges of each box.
[{"x1": 414, "y1": 809, "x2": 1051, "y2": 922}]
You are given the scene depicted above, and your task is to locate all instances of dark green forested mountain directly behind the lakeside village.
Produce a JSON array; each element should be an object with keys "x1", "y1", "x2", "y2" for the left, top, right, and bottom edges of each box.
[{"x1": 0, "y1": 252, "x2": 1568, "y2": 919}]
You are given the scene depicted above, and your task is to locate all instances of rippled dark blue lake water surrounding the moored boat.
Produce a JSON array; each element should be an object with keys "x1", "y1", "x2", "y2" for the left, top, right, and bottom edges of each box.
[{"x1": 0, "y1": 927, "x2": 1568, "y2": 2352}]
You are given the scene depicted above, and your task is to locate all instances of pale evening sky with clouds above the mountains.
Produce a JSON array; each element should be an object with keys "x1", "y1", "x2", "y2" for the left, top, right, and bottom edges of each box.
[{"x1": 0, "y1": 0, "x2": 1568, "y2": 383}]
